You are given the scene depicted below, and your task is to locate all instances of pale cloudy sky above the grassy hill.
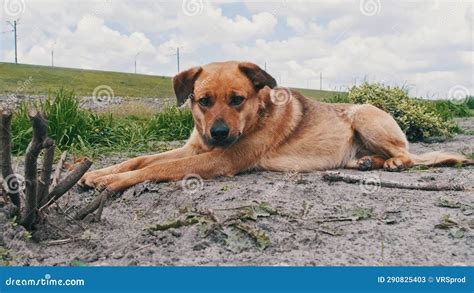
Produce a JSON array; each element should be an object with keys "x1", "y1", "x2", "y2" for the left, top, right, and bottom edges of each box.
[{"x1": 0, "y1": 0, "x2": 474, "y2": 98}]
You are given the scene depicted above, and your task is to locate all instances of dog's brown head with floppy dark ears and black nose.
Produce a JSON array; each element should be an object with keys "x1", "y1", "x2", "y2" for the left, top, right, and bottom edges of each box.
[{"x1": 173, "y1": 62, "x2": 276, "y2": 147}]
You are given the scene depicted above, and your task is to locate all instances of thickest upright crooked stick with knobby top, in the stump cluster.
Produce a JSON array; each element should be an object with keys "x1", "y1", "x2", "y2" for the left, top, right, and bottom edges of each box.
[{"x1": 22, "y1": 109, "x2": 48, "y2": 230}]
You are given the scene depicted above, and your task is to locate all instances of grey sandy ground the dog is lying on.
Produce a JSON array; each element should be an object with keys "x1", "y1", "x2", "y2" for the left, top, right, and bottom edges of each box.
[{"x1": 0, "y1": 118, "x2": 474, "y2": 266}]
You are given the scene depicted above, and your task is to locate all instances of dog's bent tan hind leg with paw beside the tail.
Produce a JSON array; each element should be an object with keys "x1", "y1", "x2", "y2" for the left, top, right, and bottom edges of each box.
[{"x1": 352, "y1": 105, "x2": 413, "y2": 171}]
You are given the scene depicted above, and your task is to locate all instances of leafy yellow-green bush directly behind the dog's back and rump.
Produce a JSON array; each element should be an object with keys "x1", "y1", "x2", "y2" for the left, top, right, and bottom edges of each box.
[{"x1": 348, "y1": 83, "x2": 456, "y2": 141}]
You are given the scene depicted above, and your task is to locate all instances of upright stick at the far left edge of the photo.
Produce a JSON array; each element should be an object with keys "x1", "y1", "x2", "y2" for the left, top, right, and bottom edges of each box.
[{"x1": 0, "y1": 110, "x2": 21, "y2": 210}]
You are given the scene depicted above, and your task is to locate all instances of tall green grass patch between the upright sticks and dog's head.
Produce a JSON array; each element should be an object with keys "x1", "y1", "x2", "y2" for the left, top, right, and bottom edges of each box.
[{"x1": 12, "y1": 89, "x2": 194, "y2": 157}]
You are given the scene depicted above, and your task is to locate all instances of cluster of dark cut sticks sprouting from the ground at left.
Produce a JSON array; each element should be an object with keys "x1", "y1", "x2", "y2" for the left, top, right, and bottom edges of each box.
[{"x1": 0, "y1": 109, "x2": 92, "y2": 230}]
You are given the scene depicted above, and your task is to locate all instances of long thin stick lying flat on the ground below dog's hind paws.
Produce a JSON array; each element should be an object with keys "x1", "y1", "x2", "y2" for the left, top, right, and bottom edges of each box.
[{"x1": 323, "y1": 171, "x2": 465, "y2": 191}]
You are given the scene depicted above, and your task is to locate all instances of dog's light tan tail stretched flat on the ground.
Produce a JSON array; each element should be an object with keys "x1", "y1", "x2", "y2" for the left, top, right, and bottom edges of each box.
[{"x1": 410, "y1": 151, "x2": 473, "y2": 166}]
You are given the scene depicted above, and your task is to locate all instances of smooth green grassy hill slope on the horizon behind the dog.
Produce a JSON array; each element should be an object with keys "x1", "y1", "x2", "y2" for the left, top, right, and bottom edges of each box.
[{"x1": 0, "y1": 63, "x2": 337, "y2": 99}]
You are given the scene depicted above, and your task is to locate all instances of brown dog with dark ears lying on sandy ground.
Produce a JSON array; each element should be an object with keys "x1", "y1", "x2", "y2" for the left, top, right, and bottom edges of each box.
[{"x1": 81, "y1": 62, "x2": 468, "y2": 191}]
